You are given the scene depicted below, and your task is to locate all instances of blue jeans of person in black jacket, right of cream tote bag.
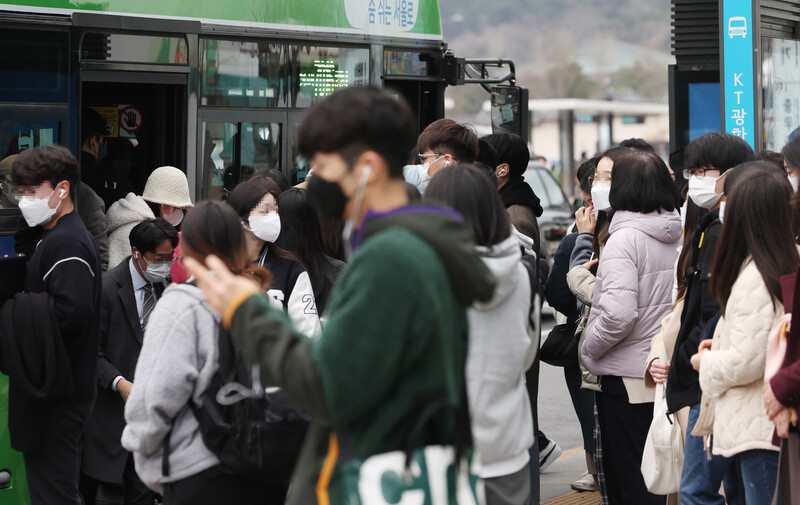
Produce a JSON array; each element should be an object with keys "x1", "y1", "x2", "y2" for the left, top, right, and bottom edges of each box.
[{"x1": 680, "y1": 405, "x2": 740, "y2": 505}]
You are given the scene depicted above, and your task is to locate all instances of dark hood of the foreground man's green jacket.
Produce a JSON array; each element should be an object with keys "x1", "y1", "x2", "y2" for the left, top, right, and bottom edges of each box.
[{"x1": 353, "y1": 202, "x2": 497, "y2": 307}]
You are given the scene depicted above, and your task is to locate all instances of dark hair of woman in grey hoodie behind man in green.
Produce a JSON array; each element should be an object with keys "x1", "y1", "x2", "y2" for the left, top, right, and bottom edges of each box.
[{"x1": 425, "y1": 164, "x2": 511, "y2": 247}]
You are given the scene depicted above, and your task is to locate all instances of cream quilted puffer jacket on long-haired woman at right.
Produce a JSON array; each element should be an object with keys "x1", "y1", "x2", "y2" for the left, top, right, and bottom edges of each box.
[{"x1": 692, "y1": 258, "x2": 783, "y2": 457}]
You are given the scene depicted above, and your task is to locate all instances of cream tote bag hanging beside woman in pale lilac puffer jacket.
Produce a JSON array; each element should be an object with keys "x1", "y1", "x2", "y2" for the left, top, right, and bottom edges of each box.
[{"x1": 641, "y1": 342, "x2": 683, "y2": 495}]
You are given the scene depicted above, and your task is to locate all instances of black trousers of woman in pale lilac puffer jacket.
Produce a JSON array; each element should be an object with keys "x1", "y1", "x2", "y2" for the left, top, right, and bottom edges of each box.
[{"x1": 597, "y1": 376, "x2": 666, "y2": 505}]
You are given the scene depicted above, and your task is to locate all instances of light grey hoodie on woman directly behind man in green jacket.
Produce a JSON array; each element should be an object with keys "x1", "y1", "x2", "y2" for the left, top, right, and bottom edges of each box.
[{"x1": 466, "y1": 233, "x2": 538, "y2": 478}]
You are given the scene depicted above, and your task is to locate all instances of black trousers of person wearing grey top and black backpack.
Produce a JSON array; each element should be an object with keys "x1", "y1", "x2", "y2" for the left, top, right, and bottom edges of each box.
[{"x1": 164, "y1": 467, "x2": 288, "y2": 505}]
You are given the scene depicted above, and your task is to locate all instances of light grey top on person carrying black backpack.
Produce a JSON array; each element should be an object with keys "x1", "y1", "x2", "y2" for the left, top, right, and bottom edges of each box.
[{"x1": 122, "y1": 284, "x2": 219, "y2": 493}]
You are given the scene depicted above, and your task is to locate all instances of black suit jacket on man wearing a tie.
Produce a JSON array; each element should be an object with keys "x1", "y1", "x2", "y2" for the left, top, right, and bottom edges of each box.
[{"x1": 81, "y1": 256, "x2": 144, "y2": 484}]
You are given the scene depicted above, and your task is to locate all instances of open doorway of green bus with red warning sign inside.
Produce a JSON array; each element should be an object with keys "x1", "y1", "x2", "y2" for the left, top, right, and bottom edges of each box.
[{"x1": 72, "y1": 13, "x2": 200, "y2": 208}]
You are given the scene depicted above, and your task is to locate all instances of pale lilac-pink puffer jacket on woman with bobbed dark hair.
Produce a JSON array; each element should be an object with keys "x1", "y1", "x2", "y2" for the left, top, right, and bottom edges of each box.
[{"x1": 581, "y1": 211, "x2": 681, "y2": 378}]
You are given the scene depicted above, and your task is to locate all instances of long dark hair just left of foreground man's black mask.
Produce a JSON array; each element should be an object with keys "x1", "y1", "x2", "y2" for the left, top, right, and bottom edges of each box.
[{"x1": 277, "y1": 188, "x2": 325, "y2": 274}]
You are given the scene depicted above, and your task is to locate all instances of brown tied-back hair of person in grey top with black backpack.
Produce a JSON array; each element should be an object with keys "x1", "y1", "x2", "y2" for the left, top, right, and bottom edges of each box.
[{"x1": 181, "y1": 201, "x2": 272, "y2": 287}]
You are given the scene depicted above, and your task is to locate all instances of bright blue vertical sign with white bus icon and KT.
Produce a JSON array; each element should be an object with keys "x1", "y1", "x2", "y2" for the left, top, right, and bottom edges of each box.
[{"x1": 722, "y1": 0, "x2": 756, "y2": 149}]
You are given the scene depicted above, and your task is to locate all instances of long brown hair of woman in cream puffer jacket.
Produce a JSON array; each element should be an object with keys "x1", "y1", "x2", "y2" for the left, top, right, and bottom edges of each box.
[{"x1": 709, "y1": 167, "x2": 800, "y2": 314}]
